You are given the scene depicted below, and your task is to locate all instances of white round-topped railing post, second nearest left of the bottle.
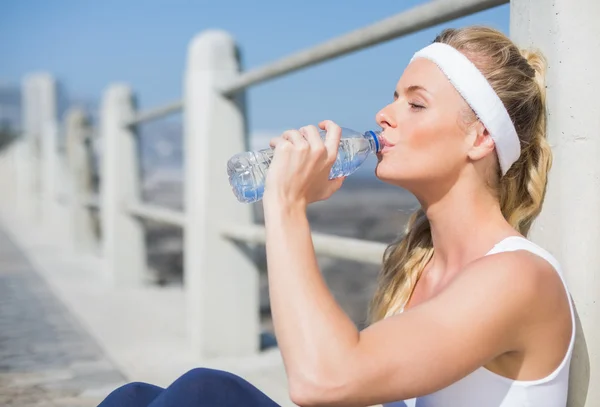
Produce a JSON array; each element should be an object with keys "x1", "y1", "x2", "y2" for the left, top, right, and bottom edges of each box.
[{"x1": 100, "y1": 84, "x2": 146, "y2": 285}]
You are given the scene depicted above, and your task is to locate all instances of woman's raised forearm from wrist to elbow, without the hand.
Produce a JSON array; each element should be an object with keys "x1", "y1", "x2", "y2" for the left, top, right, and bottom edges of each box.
[{"x1": 265, "y1": 204, "x2": 359, "y2": 388}]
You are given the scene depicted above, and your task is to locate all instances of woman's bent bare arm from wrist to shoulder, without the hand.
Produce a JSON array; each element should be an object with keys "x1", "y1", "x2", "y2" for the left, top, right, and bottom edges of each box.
[{"x1": 266, "y1": 202, "x2": 556, "y2": 406}]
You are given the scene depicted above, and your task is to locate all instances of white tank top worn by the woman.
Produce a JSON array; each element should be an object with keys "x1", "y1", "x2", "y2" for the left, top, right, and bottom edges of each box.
[{"x1": 384, "y1": 236, "x2": 576, "y2": 407}]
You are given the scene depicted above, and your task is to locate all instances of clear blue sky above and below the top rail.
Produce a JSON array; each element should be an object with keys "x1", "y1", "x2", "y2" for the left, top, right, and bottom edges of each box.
[{"x1": 0, "y1": 0, "x2": 509, "y2": 139}]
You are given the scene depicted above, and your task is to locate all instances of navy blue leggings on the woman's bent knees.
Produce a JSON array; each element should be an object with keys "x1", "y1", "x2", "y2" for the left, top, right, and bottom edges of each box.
[{"x1": 98, "y1": 368, "x2": 279, "y2": 407}]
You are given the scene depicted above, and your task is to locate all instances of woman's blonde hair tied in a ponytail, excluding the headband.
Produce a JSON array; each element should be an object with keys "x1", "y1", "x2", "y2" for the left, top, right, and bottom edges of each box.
[{"x1": 370, "y1": 27, "x2": 552, "y2": 322}]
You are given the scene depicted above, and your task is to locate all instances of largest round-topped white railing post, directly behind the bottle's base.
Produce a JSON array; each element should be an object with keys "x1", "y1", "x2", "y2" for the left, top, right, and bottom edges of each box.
[{"x1": 184, "y1": 31, "x2": 259, "y2": 357}]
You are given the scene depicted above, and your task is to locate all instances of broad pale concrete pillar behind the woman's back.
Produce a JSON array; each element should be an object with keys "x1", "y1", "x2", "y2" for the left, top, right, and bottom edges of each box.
[{"x1": 510, "y1": 0, "x2": 600, "y2": 407}]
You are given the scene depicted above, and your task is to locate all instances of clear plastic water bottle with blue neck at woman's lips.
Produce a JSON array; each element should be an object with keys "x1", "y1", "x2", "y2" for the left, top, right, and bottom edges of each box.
[{"x1": 227, "y1": 127, "x2": 383, "y2": 203}]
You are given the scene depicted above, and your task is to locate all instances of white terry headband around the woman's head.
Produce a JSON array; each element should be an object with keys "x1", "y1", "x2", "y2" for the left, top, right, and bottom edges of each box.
[{"x1": 411, "y1": 42, "x2": 521, "y2": 175}]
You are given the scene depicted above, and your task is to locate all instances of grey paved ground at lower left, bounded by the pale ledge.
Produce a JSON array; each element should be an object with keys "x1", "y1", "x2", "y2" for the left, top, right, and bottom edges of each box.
[{"x1": 0, "y1": 229, "x2": 124, "y2": 407}]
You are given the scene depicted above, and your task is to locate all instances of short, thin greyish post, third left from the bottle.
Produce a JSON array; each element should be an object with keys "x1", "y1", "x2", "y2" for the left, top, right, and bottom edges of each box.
[{"x1": 65, "y1": 108, "x2": 96, "y2": 251}]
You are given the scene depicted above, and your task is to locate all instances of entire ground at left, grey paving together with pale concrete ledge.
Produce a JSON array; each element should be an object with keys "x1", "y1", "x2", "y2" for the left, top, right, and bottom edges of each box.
[{"x1": 0, "y1": 211, "x2": 294, "y2": 407}]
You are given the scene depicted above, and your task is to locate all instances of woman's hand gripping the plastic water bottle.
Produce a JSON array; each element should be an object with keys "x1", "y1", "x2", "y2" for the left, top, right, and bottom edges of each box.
[{"x1": 263, "y1": 120, "x2": 344, "y2": 208}]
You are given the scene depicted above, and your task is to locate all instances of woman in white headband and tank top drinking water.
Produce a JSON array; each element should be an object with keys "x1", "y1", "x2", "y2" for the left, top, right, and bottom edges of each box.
[{"x1": 101, "y1": 27, "x2": 575, "y2": 407}]
